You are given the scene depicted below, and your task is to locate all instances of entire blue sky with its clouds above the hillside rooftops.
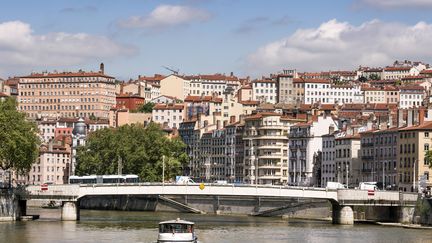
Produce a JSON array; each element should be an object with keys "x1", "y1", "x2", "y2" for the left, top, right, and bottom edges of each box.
[{"x1": 0, "y1": 0, "x2": 432, "y2": 80}]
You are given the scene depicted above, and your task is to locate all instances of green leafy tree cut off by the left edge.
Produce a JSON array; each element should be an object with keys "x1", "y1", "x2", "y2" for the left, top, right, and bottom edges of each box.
[{"x1": 0, "y1": 98, "x2": 40, "y2": 174}]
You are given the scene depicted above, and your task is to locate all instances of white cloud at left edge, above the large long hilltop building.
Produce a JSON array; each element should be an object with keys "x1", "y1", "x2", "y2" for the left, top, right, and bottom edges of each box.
[{"x1": 0, "y1": 21, "x2": 136, "y2": 75}]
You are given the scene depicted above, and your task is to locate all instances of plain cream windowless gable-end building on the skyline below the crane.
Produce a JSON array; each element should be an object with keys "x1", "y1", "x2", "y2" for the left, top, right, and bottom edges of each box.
[{"x1": 160, "y1": 74, "x2": 191, "y2": 100}]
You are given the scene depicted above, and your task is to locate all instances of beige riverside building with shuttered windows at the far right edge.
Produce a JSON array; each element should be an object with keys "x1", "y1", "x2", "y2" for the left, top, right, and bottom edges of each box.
[{"x1": 397, "y1": 121, "x2": 432, "y2": 192}]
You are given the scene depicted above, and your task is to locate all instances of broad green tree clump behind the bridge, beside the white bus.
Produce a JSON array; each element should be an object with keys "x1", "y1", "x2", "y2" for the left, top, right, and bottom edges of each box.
[{"x1": 75, "y1": 123, "x2": 189, "y2": 182}]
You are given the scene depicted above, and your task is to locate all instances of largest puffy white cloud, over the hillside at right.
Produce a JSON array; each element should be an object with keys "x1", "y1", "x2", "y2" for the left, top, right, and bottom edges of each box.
[{"x1": 245, "y1": 19, "x2": 432, "y2": 75}]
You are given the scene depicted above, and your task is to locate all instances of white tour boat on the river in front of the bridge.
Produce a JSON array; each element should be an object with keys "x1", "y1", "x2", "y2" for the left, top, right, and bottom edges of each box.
[{"x1": 157, "y1": 218, "x2": 198, "y2": 243}]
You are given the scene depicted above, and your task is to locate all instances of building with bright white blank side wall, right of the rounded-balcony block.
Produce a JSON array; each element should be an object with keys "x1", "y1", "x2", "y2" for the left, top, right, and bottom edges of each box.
[{"x1": 288, "y1": 116, "x2": 337, "y2": 185}]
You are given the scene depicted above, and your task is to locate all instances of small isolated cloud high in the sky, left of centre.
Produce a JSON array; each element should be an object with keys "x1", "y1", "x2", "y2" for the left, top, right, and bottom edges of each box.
[{"x1": 118, "y1": 5, "x2": 211, "y2": 28}]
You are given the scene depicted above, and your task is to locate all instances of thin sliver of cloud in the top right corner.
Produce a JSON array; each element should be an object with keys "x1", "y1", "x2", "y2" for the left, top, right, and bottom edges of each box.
[{"x1": 357, "y1": 0, "x2": 432, "y2": 9}]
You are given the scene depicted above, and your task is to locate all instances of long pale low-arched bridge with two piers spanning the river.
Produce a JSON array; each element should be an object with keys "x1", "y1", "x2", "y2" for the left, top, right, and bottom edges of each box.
[{"x1": 23, "y1": 183, "x2": 418, "y2": 224}]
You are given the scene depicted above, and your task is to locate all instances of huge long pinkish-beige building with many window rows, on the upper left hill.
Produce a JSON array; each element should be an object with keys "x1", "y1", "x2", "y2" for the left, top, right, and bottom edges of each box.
[{"x1": 18, "y1": 64, "x2": 116, "y2": 118}]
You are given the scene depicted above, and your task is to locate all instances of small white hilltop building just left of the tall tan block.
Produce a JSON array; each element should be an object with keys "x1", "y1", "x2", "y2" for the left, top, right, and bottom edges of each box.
[{"x1": 252, "y1": 79, "x2": 277, "y2": 104}]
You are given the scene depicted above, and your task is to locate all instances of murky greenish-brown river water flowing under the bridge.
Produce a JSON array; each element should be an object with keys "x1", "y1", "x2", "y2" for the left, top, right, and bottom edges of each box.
[{"x1": 0, "y1": 209, "x2": 432, "y2": 243}]
